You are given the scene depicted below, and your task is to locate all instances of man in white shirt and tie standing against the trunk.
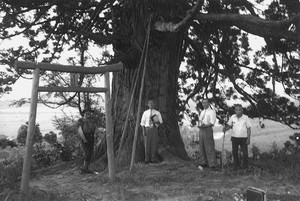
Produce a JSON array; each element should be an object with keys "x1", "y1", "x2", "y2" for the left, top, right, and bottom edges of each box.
[{"x1": 141, "y1": 100, "x2": 163, "y2": 164}]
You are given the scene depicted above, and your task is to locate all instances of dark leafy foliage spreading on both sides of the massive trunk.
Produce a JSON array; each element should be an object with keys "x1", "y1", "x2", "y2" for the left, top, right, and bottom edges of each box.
[{"x1": 0, "y1": 0, "x2": 300, "y2": 127}]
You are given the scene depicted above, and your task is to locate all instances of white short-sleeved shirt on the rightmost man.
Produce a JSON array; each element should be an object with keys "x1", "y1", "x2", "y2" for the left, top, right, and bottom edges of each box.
[{"x1": 227, "y1": 114, "x2": 251, "y2": 138}]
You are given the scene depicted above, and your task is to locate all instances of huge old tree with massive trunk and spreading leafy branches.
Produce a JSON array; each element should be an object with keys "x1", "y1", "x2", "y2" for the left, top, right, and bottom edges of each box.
[{"x1": 0, "y1": 0, "x2": 300, "y2": 164}]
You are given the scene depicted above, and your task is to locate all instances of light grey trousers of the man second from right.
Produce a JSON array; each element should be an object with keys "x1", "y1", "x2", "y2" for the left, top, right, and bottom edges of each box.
[{"x1": 199, "y1": 127, "x2": 217, "y2": 167}]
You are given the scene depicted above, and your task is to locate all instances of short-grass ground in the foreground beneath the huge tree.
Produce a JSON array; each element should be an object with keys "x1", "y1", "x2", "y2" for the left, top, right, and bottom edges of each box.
[{"x1": 30, "y1": 163, "x2": 300, "y2": 201}]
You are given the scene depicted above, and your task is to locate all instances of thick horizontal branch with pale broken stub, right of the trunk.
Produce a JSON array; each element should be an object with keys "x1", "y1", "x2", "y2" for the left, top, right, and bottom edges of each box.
[{"x1": 155, "y1": 6, "x2": 300, "y2": 42}]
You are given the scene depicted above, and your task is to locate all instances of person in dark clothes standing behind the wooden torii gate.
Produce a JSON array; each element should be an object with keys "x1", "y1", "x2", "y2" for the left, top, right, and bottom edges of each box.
[{"x1": 77, "y1": 108, "x2": 97, "y2": 174}]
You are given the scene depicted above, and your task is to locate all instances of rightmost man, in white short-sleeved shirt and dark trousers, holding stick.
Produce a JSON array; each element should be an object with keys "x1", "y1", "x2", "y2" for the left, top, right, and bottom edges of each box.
[{"x1": 223, "y1": 104, "x2": 251, "y2": 170}]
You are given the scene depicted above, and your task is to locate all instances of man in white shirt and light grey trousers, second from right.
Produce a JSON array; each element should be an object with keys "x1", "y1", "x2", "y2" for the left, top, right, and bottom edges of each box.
[{"x1": 198, "y1": 99, "x2": 217, "y2": 170}]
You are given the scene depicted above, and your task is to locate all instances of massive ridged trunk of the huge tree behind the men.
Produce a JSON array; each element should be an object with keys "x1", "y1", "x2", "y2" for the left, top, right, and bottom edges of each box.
[{"x1": 91, "y1": 0, "x2": 189, "y2": 170}]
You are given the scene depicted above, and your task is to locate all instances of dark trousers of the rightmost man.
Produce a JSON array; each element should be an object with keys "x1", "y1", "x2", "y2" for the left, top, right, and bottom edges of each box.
[{"x1": 231, "y1": 137, "x2": 248, "y2": 169}]
